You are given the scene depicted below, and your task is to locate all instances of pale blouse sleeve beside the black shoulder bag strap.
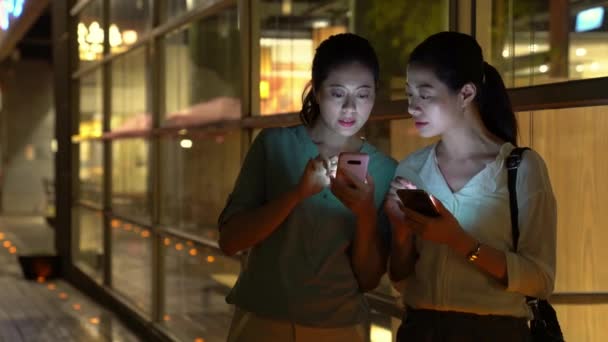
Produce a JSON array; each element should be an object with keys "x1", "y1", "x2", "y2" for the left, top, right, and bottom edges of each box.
[{"x1": 506, "y1": 151, "x2": 557, "y2": 298}]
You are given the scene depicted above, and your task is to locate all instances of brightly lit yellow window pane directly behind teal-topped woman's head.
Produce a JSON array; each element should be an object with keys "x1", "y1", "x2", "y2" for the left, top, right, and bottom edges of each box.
[{"x1": 256, "y1": 0, "x2": 350, "y2": 115}]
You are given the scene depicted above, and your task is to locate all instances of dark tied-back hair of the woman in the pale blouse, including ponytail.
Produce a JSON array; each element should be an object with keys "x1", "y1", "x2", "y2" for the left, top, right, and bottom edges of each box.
[{"x1": 409, "y1": 32, "x2": 517, "y2": 145}]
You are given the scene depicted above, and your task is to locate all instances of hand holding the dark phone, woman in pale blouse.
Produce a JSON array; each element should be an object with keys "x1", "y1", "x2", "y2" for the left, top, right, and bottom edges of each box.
[{"x1": 400, "y1": 196, "x2": 464, "y2": 245}]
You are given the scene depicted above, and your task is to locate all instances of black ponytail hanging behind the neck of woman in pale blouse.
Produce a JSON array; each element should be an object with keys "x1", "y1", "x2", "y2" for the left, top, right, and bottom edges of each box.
[{"x1": 477, "y1": 62, "x2": 517, "y2": 145}]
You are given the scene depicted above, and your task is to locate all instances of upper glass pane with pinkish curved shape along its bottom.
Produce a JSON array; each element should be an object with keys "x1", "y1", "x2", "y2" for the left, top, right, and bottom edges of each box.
[{"x1": 163, "y1": 6, "x2": 242, "y2": 126}]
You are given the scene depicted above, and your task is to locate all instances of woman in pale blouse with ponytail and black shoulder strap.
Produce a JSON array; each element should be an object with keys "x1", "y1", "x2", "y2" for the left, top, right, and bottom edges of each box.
[{"x1": 385, "y1": 32, "x2": 556, "y2": 342}]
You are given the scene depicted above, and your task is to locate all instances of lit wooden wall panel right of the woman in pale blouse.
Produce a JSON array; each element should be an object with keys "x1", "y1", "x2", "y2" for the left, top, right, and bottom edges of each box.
[{"x1": 532, "y1": 107, "x2": 608, "y2": 292}]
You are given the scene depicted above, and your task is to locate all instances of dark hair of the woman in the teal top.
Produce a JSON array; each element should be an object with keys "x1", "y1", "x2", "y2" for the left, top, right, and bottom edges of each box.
[{"x1": 300, "y1": 33, "x2": 380, "y2": 127}]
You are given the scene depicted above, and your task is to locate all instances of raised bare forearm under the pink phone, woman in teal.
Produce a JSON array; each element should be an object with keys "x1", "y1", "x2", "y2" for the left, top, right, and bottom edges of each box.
[{"x1": 351, "y1": 211, "x2": 387, "y2": 291}]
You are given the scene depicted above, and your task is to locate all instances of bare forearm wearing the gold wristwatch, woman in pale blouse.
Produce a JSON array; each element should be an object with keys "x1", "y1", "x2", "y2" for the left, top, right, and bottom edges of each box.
[{"x1": 450, "y1": 232, "x2": 508, "y2": 286}]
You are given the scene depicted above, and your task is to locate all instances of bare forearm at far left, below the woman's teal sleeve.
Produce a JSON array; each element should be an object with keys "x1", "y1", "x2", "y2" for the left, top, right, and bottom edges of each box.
[{"x1": 219, "y1": 189, "x2": 300, "y2": 255}]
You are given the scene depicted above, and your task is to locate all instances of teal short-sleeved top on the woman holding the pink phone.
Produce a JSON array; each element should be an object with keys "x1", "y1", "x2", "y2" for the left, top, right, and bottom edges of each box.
[{"x1": 219, "y1": 126, "x2": 396, "y2": 327}]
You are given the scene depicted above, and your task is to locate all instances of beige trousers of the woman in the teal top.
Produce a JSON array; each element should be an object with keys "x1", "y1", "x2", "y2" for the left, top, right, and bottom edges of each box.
[{"x1": 227, "y1": 308, "x2": 365, "y2": 342}]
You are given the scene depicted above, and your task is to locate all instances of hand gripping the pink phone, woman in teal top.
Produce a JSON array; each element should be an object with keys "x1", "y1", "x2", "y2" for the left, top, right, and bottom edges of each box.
[{"x1": 330, "y1": 169, "x2": 376, "y2": 217}]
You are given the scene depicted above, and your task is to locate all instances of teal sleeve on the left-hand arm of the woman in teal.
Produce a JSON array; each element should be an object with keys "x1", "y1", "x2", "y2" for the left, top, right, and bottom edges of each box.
[{"x1": 218, "y1": 130, "x2": 268, "y2": 227}]
